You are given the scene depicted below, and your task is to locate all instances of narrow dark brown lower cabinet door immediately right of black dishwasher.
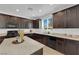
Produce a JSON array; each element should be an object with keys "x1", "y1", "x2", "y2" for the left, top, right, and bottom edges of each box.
[{"x1": 56, "y1": 38, "x2": 64, "y2": 53}]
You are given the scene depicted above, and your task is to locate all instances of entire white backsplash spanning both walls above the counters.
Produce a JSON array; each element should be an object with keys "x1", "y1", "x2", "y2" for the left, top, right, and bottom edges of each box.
[{"x1": 0, "y1": 28, "x2": 79, "y2": 35}]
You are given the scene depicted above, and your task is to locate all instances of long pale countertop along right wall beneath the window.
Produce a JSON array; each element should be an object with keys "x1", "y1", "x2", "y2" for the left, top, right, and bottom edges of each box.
[{"x1": 37, "y1": 33, "x2": 79, "y2": 41}]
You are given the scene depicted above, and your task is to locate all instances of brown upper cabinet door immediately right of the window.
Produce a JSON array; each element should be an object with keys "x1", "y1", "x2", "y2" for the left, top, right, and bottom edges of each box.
[{"x1": 53, "y1": 10, "x2": 66, "y2": 28}]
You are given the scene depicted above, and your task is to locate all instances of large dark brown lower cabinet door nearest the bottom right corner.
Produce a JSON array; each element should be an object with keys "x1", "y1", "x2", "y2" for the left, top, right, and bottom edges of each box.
[{"x1": 65, "y1": 40, "x2": 77, "y2": 55}]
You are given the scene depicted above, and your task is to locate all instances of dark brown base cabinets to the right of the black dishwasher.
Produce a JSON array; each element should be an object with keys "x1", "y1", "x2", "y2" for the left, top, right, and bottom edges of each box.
[{"x1": 56, "y1": 38, "x2": 79, "y2": 55}]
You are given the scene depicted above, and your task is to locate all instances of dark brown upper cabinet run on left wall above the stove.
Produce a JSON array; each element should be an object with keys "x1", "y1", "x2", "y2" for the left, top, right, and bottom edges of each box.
[{"x1": 0, "y1": 14, "x2": 39, "y2": 29}]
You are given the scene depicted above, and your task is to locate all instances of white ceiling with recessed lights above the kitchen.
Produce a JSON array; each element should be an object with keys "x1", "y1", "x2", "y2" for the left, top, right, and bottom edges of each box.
[{"x1": 0, "y1": 4, "x2": 74, "y2": 19}]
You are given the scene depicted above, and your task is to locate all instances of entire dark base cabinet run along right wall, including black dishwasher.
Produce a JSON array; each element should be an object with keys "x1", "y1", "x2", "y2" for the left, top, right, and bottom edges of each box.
[{"x1": 26, "y1": 34, "x2": 79, "y2": 55}]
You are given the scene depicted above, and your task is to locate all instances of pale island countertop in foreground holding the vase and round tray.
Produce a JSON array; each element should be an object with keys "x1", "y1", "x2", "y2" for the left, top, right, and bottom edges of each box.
[{"x1": 0, "y1": 36, "x2": 44, "y2": 55}]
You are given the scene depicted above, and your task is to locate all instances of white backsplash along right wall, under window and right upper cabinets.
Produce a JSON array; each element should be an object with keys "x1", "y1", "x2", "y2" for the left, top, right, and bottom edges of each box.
[{"x1": 42, "y1": 28, "x2": 79, "y2": 35}]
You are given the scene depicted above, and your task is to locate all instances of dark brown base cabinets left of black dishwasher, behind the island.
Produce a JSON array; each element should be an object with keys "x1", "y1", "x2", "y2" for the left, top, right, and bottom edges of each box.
[{"x1": 26, "y1": 33, "x2": 48, "y2": 45}]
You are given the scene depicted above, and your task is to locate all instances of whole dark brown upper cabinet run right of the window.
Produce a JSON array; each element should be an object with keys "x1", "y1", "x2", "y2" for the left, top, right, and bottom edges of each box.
[{"x1": 53, "y1": 5, "x2": 79, "y2": 28}]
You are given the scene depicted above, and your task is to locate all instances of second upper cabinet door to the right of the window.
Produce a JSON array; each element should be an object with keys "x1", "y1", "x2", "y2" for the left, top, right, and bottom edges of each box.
[{"x1": 67, "y1": 7, "x2": 77, "y2": 28}]
